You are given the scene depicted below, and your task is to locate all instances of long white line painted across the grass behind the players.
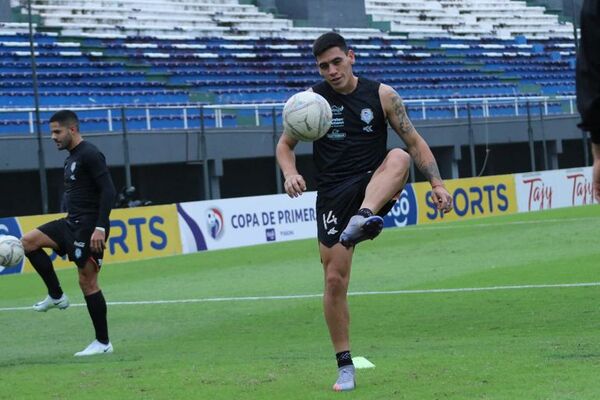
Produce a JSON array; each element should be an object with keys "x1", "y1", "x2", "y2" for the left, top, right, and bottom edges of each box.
[{"x1": 0, "y1": 282, "x2": 600, "y2": 312}]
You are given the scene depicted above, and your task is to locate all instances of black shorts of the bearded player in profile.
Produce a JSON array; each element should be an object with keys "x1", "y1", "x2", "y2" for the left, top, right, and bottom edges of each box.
[{"x1": 38, "y1": 218, "x2": 109, "y2": 268}]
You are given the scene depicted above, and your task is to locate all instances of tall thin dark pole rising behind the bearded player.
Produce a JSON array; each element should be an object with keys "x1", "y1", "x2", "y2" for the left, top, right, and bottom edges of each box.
[{"x1": 27, "y1": 0, "x2": 48, "y2": 214}]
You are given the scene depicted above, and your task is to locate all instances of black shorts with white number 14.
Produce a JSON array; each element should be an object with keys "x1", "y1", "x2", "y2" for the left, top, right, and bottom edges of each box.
[{"x1": 317, "y1": 173, "x2": 396, "y2": 247}]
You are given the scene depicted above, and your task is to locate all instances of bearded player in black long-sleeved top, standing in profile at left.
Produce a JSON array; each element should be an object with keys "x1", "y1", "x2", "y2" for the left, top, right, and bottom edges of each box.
[{"x1": 21, "y1": 110, "x2": 116, "y2": 356}]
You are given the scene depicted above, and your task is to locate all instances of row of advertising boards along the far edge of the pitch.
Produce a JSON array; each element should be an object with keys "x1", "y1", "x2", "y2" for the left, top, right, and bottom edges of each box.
[{"x1": 0, "y1": 167, "x2": 595, "y2": 275}]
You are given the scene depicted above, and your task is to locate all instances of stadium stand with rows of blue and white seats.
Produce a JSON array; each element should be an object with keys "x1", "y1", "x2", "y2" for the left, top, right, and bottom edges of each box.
[{"x1": 0, "y1": 0, "x2": 575, "y2": 133}]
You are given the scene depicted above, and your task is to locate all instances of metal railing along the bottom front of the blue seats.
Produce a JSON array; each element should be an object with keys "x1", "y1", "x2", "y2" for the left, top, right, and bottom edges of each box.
[{"x1": 0, "y1": 96, "x2": 576, "y2": 135}]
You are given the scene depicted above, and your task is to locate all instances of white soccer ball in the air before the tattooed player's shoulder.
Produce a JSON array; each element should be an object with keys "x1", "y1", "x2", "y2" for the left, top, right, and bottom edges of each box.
[{"x1": 283, "y1": 91, "x2": 331, "y2": 142}]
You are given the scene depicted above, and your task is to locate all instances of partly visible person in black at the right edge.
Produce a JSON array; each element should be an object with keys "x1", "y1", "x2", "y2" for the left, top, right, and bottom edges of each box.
[{"x1": 576, "y1": 0, "x2": 600, "y2": 202}]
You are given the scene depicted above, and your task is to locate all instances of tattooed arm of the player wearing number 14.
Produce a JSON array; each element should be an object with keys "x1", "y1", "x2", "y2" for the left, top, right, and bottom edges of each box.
[{"x1": 379, "y1": 85, "x2": 452, "y2": 212}]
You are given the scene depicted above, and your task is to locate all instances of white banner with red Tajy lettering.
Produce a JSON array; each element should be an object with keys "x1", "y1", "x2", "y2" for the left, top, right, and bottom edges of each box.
[{"x1": 515, "y1": 167, "x2": 595, "y2": 212}]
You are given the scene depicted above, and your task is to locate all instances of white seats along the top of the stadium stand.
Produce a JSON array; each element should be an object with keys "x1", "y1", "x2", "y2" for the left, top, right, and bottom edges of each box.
[{"x1": 5, "y1": 0, "x2": 573, "y2": 40}]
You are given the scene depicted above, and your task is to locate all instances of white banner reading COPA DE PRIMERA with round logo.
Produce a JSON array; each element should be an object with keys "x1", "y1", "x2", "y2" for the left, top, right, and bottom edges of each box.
[{"x1": 177, "y1": 192, "x2": 317, "y2": 253}]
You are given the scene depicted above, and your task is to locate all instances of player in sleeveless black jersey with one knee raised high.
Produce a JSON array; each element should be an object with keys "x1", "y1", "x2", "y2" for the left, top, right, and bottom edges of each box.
[{"x1": 276, "y1": 32, "x2": 452, "y2": 391}]
